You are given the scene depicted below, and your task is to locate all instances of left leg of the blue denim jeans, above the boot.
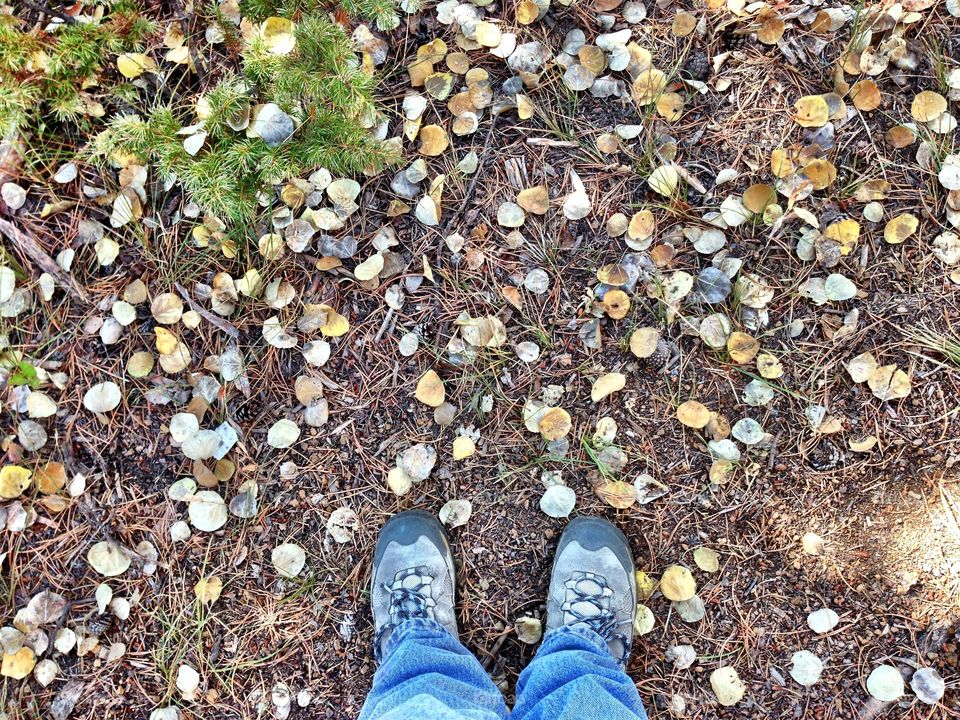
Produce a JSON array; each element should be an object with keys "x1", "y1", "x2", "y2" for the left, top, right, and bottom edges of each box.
[{"x1": 359, "y1": 618, "x2": 507, "y2": 720}]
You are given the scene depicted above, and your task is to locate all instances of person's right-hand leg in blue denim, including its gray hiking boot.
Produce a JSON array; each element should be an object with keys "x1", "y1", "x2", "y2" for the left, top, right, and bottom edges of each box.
[{"x1": 512, "y1": 517, "x2": 647, "y2": 720}]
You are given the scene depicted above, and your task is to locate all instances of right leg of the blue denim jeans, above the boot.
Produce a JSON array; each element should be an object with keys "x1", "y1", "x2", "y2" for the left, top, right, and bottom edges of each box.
[{"x1": 511, "y1": 627, "x2": 647, "y2": 720}]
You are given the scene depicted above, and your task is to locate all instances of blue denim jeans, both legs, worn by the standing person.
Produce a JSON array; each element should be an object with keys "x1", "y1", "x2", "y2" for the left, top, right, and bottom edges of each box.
[{"x1": 360, "y1": 618, "x2": 647, "y2": 720}]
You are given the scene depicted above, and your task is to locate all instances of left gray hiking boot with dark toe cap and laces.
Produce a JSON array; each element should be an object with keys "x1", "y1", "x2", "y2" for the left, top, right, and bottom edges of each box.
[{"x1": 370, "y1": 510, "x2": 457, "y2": 660}]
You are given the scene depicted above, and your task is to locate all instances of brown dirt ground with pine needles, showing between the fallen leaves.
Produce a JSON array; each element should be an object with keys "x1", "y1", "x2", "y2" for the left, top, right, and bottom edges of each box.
[{"x1": 0, "y1": 4, "x2": 960, "y2": 720}]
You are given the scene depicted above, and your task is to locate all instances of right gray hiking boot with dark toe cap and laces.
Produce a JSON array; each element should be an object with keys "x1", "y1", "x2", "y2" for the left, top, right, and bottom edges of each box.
[{"x1": 547, "y1": 517, "x2": 637, "y2": 665}]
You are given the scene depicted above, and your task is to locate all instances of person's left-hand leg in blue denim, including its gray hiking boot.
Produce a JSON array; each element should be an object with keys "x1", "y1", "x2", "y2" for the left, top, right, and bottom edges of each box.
[{"x1": 360, "y1": 510, "x2": 507, "y2": 720}]
